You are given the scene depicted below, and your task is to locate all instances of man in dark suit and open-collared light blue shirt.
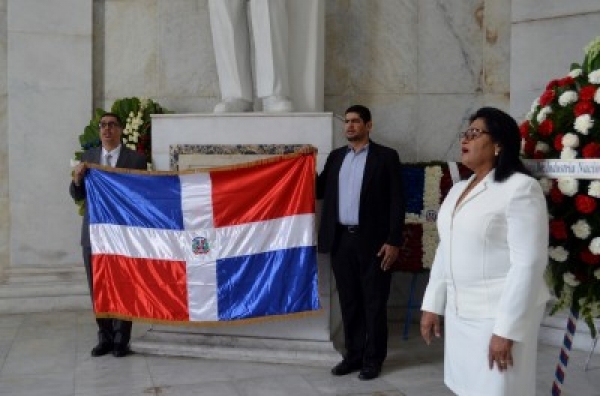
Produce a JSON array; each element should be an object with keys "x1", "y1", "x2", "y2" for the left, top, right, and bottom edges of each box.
[{"x1": 317, "y1": 105, "x2": 404, "y2": 380}]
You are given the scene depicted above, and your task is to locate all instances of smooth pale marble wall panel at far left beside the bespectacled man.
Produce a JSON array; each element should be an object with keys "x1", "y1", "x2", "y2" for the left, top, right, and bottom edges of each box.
[{"x1": 0, "y1": 0, "x2": 92, "y2": 267}]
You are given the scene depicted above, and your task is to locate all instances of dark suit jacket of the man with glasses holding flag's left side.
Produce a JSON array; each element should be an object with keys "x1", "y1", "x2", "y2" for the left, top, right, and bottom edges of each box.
[{"x1": 69, "y1": 146, "x2": 148, "y2": 246}]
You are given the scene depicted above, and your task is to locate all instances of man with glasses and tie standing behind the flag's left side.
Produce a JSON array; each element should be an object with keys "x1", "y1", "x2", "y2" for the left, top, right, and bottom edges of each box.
[{"x1": 69, "y1": 113, "x2": 147, "y2": 357}]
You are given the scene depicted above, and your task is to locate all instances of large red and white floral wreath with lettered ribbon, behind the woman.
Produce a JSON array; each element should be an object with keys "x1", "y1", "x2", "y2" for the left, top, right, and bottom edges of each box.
[{"x1": 520, "y1": 37, "x2": 600, "y2": 337}]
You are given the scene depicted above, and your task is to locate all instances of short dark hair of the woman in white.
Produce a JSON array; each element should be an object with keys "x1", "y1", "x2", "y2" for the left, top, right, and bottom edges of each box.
[{"x1": 469, "y1": 107, "x2": 531, "y2": 182}]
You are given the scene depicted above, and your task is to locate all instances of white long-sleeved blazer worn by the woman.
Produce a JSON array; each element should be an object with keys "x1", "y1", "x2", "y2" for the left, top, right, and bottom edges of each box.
[{"x1": 422, "y1": 170, "x2": 550, "y2": 341}]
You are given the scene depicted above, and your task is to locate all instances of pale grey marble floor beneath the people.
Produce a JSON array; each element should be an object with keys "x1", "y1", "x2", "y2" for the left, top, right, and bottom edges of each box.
[{"x1": 0, "y1": 311, "x2": 600, "y2": 396}]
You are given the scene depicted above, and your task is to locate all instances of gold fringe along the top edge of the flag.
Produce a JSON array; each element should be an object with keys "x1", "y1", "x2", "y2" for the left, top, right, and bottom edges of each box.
[{"x1": 85, "y1": 145, "x2": 317, "y2": 176}]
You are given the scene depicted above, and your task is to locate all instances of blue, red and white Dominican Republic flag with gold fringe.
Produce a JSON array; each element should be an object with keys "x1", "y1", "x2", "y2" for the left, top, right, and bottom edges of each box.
[{"x1": 85, "y1": 154, "x2": 320, "y2": 322}]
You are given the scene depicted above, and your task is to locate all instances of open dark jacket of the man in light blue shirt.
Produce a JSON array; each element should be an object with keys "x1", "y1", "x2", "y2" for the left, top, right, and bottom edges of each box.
[{"x1": 317, "y1": 141, "x2": 405, "y2": 254}]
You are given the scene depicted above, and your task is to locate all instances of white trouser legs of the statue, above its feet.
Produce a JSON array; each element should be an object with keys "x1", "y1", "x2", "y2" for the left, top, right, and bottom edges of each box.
[{"x1": 208, "y1": 0, "x2": 290, "y2": 102}]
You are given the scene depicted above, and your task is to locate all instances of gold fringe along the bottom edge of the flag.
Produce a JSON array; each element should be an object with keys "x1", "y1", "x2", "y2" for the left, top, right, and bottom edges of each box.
[{"x1": 96, "y1": 308, "x2": 324, "y2": 327}]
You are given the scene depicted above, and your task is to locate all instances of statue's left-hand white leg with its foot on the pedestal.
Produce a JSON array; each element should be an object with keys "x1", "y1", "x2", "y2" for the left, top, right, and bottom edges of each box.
[{"x1": 208, "y1": 0, "x2": 252, "y2": 112}]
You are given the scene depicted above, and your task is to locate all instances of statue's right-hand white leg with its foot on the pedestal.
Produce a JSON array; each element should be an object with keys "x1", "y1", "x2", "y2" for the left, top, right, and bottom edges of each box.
[{"x1": 250, "y1": 0, "x2": 292, "y2": 112}]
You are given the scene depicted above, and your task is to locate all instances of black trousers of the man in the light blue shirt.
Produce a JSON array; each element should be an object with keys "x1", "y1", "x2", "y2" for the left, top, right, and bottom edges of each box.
[{"x1": 331, "y1": 228, "x2": 392, "y2": 366}]
